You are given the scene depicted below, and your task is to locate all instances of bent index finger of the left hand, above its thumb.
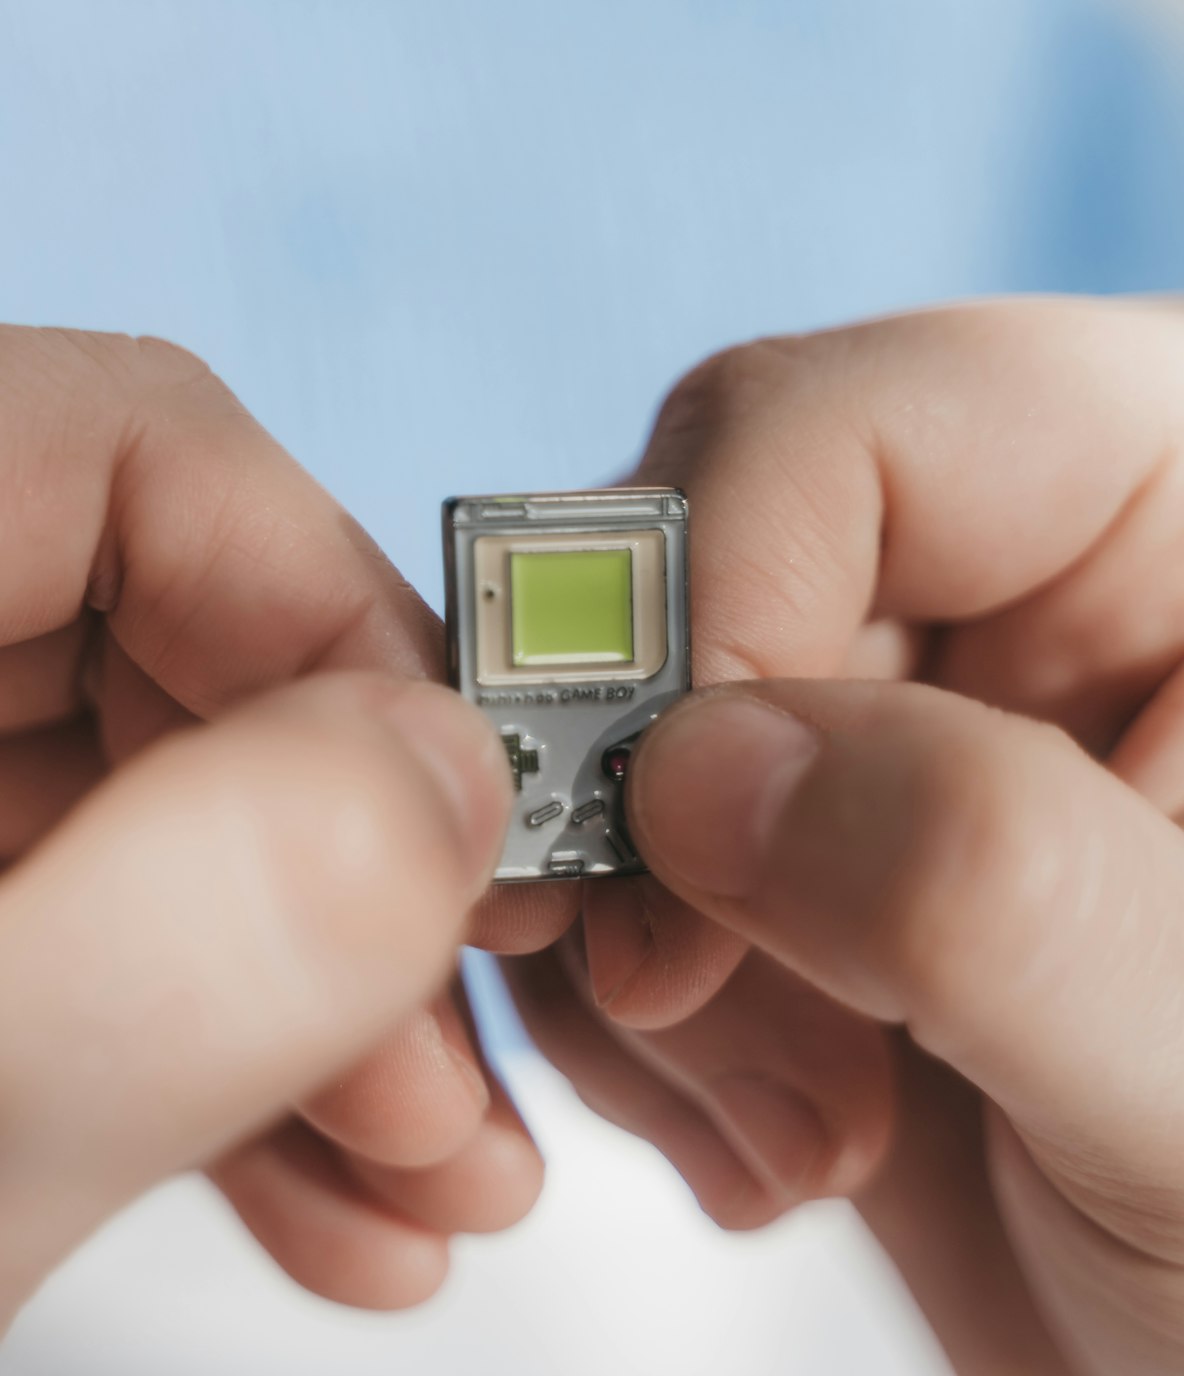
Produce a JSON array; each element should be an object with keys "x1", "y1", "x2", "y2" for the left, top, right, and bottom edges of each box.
[{"x1": 0, "y1": 326, "x2": 442, "y2": 717}]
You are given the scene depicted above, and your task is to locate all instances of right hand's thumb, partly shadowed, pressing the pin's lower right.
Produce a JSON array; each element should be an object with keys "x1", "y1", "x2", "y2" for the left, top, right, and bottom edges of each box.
[{"x1": 628, "y1": 681, "x2": 1184, "y2": 1240}]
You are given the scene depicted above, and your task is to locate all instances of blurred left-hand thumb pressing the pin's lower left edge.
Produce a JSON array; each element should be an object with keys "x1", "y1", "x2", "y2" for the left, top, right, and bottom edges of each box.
[{"x1": 0, "y1": 674, "x2": 509, "y2": 1322}]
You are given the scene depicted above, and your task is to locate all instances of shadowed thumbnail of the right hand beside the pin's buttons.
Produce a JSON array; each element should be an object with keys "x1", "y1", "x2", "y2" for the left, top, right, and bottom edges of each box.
[{"x1": 629, "y1": 694, "x2": 818, "y2": 899}]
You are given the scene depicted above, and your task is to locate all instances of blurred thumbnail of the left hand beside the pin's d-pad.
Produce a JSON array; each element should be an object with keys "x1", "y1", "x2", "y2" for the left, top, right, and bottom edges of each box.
[{"x1": 376, "y1": 684, "x2": 509, "y2": 874}]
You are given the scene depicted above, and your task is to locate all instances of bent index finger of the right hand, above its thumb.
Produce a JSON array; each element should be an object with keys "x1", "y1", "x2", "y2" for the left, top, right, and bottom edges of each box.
[{"x1": 640, "y1": 299, "x2": 1184, "y2": 682}]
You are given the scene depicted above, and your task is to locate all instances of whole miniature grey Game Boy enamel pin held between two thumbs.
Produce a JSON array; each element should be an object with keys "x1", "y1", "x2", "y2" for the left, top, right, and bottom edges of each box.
[{"x1": 443, "y1": 487, "x2": 690, "y2": 879}]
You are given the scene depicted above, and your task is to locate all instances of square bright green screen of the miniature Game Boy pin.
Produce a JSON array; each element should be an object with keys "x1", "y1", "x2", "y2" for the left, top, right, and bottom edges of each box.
[{"x1": 509, "y1": 549, "x2": 633, "y2": 666}]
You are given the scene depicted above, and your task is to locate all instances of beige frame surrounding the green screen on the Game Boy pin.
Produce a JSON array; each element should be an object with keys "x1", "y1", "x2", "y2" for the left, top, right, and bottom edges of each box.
[{"x1": 472, "y1": 530, "x2": 668, "y2": 687}]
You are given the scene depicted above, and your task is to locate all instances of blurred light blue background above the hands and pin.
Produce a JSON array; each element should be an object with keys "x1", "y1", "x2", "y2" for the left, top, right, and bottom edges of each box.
[{"x1": 0, "y1": 0, "x2": 1184, "y2": 1034}]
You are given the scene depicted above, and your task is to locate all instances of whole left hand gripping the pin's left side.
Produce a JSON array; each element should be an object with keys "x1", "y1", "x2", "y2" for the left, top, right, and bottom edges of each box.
[{"x1": 0, "y1": 329, "x2": 540, "y2": 1329}]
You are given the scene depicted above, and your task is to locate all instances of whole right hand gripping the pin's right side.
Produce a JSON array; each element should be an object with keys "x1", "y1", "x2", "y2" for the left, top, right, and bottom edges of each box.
[{"x1": 514, "y1": 301, "x2": 1184, "y2": 1376}]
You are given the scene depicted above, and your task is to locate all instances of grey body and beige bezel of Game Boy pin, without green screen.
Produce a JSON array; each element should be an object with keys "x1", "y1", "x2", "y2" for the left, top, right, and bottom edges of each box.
[{"x1": 443, "y1": 488, "x2": 690, "y2": 881}]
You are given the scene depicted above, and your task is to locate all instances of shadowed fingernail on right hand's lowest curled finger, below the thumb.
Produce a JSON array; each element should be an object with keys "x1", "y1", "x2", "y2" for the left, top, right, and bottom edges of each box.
[{"x1": 712, "y1": 1075, "x2": 827, "y2": 1197}]
